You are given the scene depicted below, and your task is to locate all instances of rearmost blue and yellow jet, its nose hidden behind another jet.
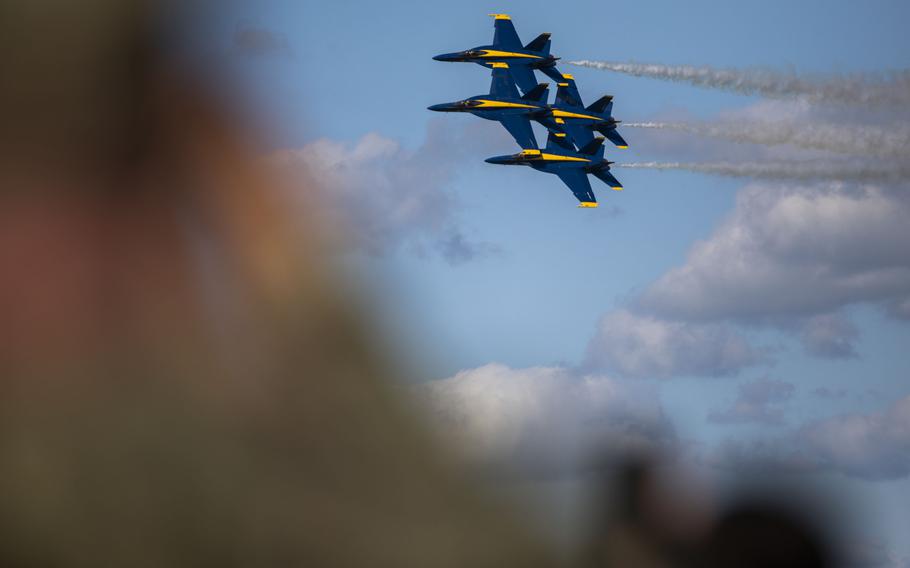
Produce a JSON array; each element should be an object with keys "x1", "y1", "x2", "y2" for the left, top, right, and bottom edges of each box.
[{"x1": 544, "y1": 74, "x2": 629, "y2": 149}]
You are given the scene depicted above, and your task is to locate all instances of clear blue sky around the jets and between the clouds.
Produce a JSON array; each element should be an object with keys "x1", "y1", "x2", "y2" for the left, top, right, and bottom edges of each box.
[{"x1": 192, "y1": 0, "x2": 910, "y2": 565}]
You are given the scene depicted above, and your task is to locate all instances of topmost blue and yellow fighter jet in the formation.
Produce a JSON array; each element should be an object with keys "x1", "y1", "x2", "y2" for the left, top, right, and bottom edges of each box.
[{"x1": 433, "y1": 14, "x2": 562, "y2": 93}]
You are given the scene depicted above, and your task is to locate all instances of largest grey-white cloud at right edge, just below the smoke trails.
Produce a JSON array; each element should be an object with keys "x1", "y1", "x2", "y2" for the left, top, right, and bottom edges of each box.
[{"x1": 640, "y1": 184, "x2": 910, "y2": 320}]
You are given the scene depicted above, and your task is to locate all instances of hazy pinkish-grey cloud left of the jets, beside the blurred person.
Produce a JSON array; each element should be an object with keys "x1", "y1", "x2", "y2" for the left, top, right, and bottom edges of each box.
[{"x1": 269, "y1": 122, "x2": 497, "y2": 263}]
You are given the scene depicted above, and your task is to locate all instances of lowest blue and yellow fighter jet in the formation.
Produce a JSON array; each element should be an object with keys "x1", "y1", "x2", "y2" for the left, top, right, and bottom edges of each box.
[{"x1": 486, "y1": 132, "x2": 622, "y2": 207}]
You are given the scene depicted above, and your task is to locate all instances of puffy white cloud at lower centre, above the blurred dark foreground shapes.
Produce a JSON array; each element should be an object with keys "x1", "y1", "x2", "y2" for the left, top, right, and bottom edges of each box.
[{"x1": 418, "y1": 364, "x2": 674, "y2": 476}]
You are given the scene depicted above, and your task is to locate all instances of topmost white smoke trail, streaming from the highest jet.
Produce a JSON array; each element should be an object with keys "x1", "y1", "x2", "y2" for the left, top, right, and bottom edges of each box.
[{"x1": 568, "y1": 59, "x2": 910, "y2": 106}]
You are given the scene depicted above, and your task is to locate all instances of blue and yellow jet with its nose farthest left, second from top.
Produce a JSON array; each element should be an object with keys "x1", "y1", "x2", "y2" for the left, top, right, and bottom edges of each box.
[{"x1": 427, "y1": 63, "x2": 550, "y2": 150}]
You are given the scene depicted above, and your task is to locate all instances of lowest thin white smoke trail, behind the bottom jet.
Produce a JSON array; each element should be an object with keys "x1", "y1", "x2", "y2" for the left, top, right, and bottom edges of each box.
[{"x1": 613, "y1": 161, "x2": 910, "y2": 182}]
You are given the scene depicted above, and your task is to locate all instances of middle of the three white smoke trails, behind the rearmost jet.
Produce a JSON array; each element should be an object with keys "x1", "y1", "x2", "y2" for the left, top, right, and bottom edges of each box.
[{"x1": 623, "y1": 121, "x2": 910, "y2": 158}]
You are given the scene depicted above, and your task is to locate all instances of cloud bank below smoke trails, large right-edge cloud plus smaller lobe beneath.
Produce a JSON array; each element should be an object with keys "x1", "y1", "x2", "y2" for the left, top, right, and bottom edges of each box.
[{"x1": 583, "y1": 179, "x2": 910, "y2": 372}]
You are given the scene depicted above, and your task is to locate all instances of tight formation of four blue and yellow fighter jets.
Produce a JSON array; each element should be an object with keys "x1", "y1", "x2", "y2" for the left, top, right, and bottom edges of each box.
[{"x1": 429, "y1": 14, "x2": 629, "y2": 207}]
